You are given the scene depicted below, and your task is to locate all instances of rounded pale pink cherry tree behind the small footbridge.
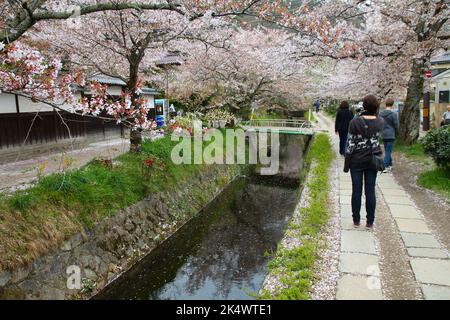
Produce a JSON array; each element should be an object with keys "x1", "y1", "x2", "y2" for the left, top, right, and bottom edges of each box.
[{"x1": 172, "y1": 27, "x2": 308, "y2": 116}]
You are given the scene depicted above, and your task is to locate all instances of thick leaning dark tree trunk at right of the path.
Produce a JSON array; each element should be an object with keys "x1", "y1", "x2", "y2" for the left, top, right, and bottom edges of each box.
[{"x1": 400, "y1": 60, "x2": 425, "y2": 145}]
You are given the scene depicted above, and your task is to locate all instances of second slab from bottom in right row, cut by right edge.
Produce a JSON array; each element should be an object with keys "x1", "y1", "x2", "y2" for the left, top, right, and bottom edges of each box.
[{"x1": 411, "y1": 258, "x2": 450, "y2": 286}]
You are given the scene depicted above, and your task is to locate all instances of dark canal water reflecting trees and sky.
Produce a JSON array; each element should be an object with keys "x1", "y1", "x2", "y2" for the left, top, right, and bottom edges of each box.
[{"x1": 95, "y1": 137, "x2": 304, "y2": 300}]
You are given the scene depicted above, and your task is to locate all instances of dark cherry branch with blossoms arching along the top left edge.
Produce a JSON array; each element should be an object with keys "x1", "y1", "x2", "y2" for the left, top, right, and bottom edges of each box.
[{"x1": 0, "y1": 0, "x2": 278, "y2": 43}]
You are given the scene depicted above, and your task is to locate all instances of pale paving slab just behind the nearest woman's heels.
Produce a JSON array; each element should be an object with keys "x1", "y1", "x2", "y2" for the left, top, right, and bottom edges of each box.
[{"x1": 341, "y1": 230, "x2": 376, "y2": 254}]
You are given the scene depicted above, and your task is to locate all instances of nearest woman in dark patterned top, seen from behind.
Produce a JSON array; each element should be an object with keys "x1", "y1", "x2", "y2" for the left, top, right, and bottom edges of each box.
[{"x1": 344, "y1": 95, "x2": 384, "y2": 229}]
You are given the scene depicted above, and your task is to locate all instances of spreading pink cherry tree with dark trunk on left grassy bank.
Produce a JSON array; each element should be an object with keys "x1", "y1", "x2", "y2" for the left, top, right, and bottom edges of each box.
[{"x1": 36, "y1": 6, "x2": 253, "y2": 151}]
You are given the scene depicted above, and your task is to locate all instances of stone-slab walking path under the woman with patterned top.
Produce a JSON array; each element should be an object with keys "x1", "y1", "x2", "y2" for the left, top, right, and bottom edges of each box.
[{"x1": 317, "y1": 115, "x2": 450, "y2": 300}]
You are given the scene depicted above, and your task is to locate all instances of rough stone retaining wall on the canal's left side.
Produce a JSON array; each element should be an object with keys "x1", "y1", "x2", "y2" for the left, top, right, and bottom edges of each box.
[{"x1": 0, "y1": 166, "x2": 248, "y2": 299}]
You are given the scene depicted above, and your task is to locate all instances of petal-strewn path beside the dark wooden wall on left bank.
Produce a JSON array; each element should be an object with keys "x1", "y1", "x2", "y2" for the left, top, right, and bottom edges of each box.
[{"x1": 0, "y1": 139, "x2": 129, "y2": 192}]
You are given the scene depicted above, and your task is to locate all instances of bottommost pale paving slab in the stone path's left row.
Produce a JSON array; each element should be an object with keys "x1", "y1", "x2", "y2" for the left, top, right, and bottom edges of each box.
[{"x1": 336, "y1": 275, "x2": 383, "y2": 300}]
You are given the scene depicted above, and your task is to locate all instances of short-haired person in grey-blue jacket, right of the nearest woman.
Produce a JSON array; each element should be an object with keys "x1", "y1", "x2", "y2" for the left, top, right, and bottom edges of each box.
[{"x1": 380, "y1": 99, "x2": 400, "y2": 173}]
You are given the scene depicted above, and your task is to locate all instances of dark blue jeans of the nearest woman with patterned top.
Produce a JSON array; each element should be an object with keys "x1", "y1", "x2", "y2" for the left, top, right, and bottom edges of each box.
[{"x1": 350, "y1": 161, "x2": 378, "y2": 224}]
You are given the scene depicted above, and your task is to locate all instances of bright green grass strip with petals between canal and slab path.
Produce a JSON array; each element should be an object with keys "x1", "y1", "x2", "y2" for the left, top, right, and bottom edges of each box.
[{"x1": 259, "y1": 134, "x2": 334, "y2": 300}]
